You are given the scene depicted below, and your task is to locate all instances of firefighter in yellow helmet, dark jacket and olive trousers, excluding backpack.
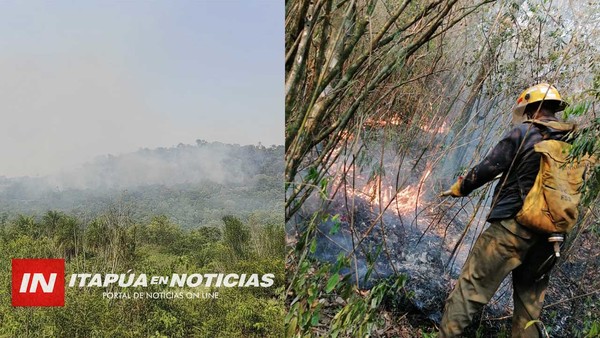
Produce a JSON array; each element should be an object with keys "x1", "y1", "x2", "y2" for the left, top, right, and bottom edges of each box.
[{"x1": 439, "y1": 83, "x2": 573, "y2": 337}]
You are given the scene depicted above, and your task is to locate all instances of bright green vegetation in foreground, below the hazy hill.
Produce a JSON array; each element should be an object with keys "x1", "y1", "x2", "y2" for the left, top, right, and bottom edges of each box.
[{"x1": 0, "y1": 210, "x2": 285, "y2": 337}]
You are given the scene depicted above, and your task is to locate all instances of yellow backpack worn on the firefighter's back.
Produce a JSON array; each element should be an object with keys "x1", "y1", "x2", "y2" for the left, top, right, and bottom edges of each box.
[{"x1": 516, "y1": 120, "x2": 594, "y2": 233}]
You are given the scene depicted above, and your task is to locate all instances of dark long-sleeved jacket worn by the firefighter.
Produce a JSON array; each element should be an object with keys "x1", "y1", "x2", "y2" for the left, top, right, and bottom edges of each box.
[{"x1": 461, "y1": 117, "x2": 574, "y2": 222}]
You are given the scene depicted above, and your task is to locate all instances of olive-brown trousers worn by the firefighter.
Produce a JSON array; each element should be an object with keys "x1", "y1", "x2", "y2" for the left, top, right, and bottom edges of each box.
[{"x1": 439, "y1": 219, "x2": 554, "y2": 338}]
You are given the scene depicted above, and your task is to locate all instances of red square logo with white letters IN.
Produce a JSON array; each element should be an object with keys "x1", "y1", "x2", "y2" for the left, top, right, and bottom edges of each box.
[{"x1": 12, "y1": 258, "x2": 65, "y2": 306}]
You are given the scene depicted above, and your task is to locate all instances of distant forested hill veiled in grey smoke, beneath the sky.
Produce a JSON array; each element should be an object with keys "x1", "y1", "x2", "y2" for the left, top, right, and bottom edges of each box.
[{"x1": 0, "y1": 140, "x2": 283, "y2": 227}]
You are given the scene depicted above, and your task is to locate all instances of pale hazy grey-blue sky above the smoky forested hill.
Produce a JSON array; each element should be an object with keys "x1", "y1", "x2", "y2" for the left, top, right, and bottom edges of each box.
[{"x1": 0, "y1": 0, "x2": 284, "y2": 177}]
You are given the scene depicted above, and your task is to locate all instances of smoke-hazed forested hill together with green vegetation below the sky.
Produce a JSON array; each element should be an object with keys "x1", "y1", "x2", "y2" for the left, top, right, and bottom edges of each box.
[{"x1": 0, "y1": 140, "x2": 285, "y2": 337}]
